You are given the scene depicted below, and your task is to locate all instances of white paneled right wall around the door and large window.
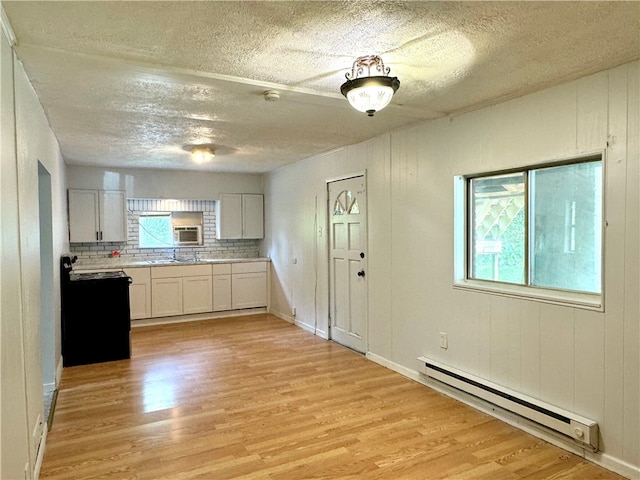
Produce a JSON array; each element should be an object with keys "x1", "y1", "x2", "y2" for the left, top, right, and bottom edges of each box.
[{"x1": 262, "y1": 62, "x2": 640, "y2": 476}]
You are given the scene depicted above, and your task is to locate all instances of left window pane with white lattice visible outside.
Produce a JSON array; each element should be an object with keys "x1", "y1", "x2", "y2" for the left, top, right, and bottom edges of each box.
[{"x1": 470, "y1": 172, "x2": 525, "y2": 284}]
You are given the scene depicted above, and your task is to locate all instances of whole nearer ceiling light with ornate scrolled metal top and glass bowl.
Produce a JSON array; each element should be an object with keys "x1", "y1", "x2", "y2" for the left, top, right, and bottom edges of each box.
[{"x1": 340, "y1": 55, "x2": 400, "y2": 117}]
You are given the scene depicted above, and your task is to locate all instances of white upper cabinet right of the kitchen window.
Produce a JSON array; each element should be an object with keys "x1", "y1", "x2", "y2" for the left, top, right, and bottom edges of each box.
[{"x1": 216, "y1": 193, "x2": 264, "y2": 240}]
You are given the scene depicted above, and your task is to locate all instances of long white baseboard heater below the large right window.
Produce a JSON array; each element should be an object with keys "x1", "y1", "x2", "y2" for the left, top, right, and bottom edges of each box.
[{"x1": 418, "y1": 357, "x2": 599, "y2": 452}]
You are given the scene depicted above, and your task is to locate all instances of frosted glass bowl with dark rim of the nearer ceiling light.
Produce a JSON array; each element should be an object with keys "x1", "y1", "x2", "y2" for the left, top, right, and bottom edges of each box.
[{"x1": 340, "y1": 76, "x2": 400, "y2": 117}]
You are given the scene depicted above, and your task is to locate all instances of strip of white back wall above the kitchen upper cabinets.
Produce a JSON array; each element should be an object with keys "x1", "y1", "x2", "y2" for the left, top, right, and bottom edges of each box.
[{"x1": 67, "y1": 165, "x2": 263, "y2": 200}]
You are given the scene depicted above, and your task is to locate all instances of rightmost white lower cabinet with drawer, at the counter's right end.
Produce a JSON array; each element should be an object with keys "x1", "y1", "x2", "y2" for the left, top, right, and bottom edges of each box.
[{"x1": 231, "y1": 262, "x2": 267, "y2": 310}]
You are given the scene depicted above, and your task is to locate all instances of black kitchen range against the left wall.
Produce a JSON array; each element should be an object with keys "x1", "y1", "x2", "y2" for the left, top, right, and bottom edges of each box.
[{"x1": 60, "y1": 255, "x2": 131, "y2": 367}]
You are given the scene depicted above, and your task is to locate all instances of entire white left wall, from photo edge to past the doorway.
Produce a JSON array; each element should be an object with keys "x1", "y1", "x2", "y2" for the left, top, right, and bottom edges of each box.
[{"x1": 0, "y1": 17, "x2": 68, "y2": 478}]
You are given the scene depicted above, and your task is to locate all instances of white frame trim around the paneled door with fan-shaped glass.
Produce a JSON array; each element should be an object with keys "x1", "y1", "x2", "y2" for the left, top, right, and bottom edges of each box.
[{"x1": 324, "y1": 169, "x2": 369, "y2": 355}]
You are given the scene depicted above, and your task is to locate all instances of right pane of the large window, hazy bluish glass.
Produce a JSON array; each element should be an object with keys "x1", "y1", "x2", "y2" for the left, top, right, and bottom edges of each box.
[{"x1": 531, "y1": 162, "x2": 602, "y2": 293}]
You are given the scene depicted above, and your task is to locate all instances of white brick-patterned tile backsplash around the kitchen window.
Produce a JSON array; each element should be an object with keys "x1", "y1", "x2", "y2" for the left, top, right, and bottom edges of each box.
[{"x1": 70, "y1": 198, "x2": 260, "y2": 260}]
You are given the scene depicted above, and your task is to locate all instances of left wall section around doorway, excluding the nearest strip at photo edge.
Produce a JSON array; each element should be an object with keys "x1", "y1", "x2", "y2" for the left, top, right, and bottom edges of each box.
[{"x1": 14, "y1": 38, "x2": 68, "y2": 466}]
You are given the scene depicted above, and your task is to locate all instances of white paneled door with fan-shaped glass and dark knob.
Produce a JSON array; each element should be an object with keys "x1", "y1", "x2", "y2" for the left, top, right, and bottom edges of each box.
[{"x1": 328, "y1": 176, "x2": 367, "y2": 353}]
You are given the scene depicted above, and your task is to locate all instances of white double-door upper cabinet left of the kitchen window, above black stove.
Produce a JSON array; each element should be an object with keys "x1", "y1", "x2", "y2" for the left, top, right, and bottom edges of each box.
[{"x1": 69, "y1": 190, "x2": 127, "y2": 243}]
